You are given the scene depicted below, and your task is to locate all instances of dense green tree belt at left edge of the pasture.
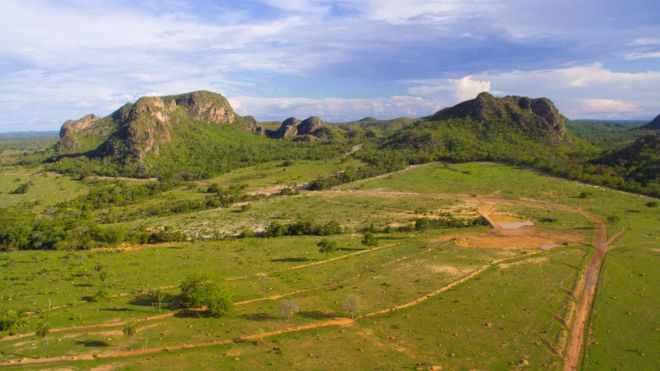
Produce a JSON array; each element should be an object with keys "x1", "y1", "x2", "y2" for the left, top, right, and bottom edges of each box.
[{"x1": 0, "y1": 181, "x2": 253, "y2": 251}]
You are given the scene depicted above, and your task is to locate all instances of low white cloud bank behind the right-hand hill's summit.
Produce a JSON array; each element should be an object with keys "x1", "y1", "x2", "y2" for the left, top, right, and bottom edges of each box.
[{"x1": 408, "y1": 64, "x2": 660, "y2": 119}]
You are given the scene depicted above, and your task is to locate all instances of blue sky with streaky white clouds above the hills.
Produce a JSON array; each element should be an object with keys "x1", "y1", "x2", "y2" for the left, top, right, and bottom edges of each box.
[{"x1": 0, "y1": 0, "x2": 660, "y2": 132}]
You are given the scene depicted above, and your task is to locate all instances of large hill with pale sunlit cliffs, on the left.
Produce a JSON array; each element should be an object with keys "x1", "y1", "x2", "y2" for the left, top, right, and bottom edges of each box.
[{"x1": 50, "y1": 91, "x2": 348, "y2": 178}]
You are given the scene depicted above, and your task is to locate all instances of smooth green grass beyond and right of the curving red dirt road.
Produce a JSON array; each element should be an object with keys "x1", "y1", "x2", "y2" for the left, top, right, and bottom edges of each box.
[{"x1": 347, "y1": 163, "x2": 660, "y2": 369}]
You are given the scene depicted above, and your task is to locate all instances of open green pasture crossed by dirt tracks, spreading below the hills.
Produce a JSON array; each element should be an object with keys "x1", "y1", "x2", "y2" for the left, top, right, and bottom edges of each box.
[{"x1": 0, "y1": 159, "x2": 660, "y2": 370}]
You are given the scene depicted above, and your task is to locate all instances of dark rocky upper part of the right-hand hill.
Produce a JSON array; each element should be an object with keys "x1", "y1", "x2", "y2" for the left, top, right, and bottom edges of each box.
[{"x1": 431, "y1": 92, "x2": 568, "y2": 144}]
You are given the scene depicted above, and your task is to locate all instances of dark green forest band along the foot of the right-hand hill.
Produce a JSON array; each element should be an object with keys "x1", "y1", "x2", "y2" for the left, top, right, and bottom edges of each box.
[{"x1": 308, "y1": 122, "x2": 660, "y2": 197}]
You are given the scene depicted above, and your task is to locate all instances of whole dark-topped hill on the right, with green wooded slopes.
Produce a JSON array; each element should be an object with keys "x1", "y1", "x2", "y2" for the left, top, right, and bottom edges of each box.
[{"x1": 380, "y1": 93, "x2": 591, "y2": 163}]
